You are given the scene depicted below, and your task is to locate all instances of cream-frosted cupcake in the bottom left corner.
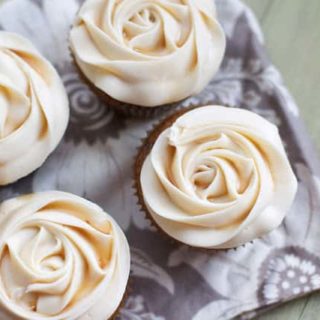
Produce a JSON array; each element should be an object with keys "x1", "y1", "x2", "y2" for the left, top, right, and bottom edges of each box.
[{"x1": 0, "y1": 191, "x2": 130, "y2": 320}]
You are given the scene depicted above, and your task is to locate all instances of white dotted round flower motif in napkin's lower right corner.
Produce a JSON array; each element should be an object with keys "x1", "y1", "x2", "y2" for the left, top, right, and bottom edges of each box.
[{"x1": 258, "y1": 247, "x2": 320, "y2": 303}]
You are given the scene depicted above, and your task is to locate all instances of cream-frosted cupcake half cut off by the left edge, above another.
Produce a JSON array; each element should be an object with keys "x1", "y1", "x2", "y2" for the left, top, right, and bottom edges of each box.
[{"x1": 0, "y1": 31, "x2": 69, "y2": 185}]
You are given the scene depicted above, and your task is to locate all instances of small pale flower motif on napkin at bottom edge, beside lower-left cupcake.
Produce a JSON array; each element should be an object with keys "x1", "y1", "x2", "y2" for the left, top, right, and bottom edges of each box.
[{"x1": 117, "y1": 295, "x2": 165, "y2": 320}]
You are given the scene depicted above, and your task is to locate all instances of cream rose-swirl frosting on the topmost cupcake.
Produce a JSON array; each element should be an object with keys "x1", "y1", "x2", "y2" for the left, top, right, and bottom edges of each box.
[{"x1": 70, "y1": 0, "x2": 226, "y2": 107}]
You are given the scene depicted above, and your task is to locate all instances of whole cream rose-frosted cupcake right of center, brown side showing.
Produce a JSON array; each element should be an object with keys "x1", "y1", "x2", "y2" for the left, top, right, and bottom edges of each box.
[{"x1": 136, "y1": 106, "x2": 297, "y2": 249}]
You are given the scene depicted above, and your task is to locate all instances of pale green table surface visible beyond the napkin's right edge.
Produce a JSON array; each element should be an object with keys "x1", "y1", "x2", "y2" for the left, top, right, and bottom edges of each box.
[{"x1": 244, "y1": 0, "x2": 320, "y2": 320}]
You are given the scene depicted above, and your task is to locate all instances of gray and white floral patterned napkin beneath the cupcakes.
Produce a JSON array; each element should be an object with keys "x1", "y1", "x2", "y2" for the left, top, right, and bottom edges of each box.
[{"x1": 0, "y1": 0, "x2": 320, "y2": 320}]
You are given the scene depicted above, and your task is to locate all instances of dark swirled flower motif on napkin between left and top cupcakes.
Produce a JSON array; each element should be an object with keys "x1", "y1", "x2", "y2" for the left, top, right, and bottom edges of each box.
[{"x1": 62, "y1": 71, "x2": 125, "y2": 144}]
